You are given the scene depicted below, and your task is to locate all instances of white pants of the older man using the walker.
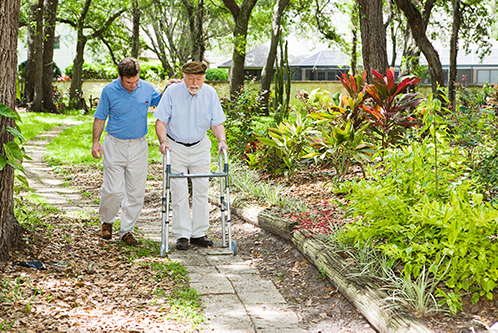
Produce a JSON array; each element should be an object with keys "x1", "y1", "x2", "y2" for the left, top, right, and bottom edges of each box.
[{"x1": 169, "y1": 136, "x2": 211, "y2": 239}]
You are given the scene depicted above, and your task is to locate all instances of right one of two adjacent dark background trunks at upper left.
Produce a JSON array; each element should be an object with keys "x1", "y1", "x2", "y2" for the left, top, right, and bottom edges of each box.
[{"x1": 42, "y1": 0, "x2": 59, "y2": 113}]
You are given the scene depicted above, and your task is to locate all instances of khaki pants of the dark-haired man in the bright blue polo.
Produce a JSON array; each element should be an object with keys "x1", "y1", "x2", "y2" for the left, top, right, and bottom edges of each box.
[{"x1": 99, "y1": 134, "x2": 148, "y2": 237}]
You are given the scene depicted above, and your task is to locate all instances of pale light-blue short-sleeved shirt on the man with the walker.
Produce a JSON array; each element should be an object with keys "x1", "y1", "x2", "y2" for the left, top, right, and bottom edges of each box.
[{"x1": 154, "y1": 82, "x2": 226, "y2": 143}]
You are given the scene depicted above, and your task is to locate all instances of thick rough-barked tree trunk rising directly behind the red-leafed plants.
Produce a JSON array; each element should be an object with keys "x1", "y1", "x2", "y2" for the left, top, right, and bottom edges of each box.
[{"x1": 357, "y1": 0, "x2": 389, "y2": 82}]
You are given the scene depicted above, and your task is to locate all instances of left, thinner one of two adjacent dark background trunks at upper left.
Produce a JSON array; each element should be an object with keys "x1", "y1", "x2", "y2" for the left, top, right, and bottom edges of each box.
[{"x1": 32, "y1": 0, "x2": 44, "y2": 112}]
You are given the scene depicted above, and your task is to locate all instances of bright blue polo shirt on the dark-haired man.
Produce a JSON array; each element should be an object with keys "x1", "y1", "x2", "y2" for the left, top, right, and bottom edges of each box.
[{"x1": 94, "y1": 79, "x2": 161, "y2": 140}]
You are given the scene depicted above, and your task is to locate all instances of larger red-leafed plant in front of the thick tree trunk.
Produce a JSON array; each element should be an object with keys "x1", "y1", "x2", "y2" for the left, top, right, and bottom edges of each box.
[{"x1": 361, "y1": 68, "x2": 422, "y2": 148}]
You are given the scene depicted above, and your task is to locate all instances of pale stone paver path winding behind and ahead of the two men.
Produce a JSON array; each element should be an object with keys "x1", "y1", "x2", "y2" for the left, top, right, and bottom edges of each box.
[{"x1": 24, "y1": 122, "x2": 306, "y2": 333}]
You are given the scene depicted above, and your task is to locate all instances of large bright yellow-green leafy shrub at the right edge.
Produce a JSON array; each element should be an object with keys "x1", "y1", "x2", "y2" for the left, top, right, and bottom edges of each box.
[{"x1": 347, "y1": 140, "x2": 498, "y2": 313}]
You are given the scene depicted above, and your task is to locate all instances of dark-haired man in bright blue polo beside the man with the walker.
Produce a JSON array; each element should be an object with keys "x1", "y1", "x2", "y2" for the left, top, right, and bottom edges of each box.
[{"x1": 92, "y1": 58, "x2": 161, "y2": 245}]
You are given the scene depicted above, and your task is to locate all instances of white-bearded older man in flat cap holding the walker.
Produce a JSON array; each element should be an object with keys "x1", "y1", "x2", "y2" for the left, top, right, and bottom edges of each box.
[{"x1": 154, "y1": 61, "x2": 228, "y2": 250}]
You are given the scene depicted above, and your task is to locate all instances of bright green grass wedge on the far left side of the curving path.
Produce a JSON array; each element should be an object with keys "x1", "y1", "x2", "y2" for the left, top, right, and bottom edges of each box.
[{"x1": 18, "y1": 112, "x2": 91, "y2": 141}]
